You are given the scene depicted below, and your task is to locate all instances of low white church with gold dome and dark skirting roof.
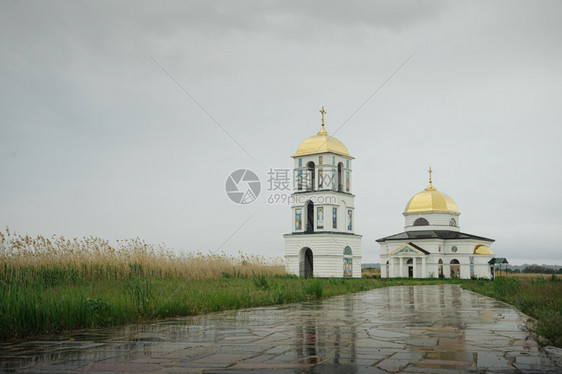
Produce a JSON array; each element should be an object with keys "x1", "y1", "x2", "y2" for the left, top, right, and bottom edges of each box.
[{"x1": 377, "y1": 168, "x2": 495, "y2": 279}]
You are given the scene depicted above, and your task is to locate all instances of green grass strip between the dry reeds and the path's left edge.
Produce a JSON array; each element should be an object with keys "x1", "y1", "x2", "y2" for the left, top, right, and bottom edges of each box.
[{"x1": 0, "y1": 274, "x2": 464, "y2": 339}]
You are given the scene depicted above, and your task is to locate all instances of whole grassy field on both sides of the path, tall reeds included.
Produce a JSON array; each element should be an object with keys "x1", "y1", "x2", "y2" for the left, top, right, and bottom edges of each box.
[{"x1": 0, "y1": 230, "x2": 562, "y2": 346}]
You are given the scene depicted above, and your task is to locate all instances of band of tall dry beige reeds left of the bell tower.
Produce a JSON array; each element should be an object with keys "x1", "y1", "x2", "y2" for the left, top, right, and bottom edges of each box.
[{"x1": 0, "y1": 228, "x2": 285, "y2": 285}]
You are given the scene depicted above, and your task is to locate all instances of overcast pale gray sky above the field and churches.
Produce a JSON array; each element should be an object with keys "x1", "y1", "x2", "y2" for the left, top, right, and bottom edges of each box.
[{"x1": 0, "y1": 1, "x2": 562, "y2": 264}]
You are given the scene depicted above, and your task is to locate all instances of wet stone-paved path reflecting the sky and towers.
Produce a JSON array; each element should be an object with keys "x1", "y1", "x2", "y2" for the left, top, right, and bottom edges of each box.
[{"x1": 0, "y1": 285, "x2": 562, "y2": 374}]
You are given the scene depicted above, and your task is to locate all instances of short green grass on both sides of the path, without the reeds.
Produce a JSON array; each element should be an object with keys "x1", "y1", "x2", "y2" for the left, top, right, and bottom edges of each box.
[{"x1": 0, "y1": 271, "x2": 562, "y2": 347}]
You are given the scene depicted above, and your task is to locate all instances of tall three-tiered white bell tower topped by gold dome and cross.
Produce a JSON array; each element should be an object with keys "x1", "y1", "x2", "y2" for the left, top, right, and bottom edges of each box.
[{"x1": 283, "y1": 107, "x2": 362, "y2": 278}]
